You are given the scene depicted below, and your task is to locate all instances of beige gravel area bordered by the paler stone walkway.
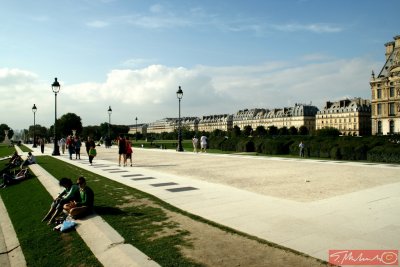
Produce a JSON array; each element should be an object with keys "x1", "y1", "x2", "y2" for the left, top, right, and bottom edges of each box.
[{"x1": 98, "y1": 148, "x2": 400, "y2": 202}]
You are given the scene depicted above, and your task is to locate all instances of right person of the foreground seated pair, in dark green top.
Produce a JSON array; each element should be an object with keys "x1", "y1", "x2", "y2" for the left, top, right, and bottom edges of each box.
[{"x1": 64, "y1": 176, "x2": 94, "y2": 219}]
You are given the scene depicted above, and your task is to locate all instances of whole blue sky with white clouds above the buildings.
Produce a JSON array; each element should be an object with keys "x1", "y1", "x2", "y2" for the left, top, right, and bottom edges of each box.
[{"x1": 0, "y1": 0, "x2": 400, "y2": 130}]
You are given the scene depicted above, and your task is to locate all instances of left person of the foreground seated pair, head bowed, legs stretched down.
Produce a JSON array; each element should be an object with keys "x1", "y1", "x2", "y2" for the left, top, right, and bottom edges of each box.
[{"x1": 42, "y1": 177, "x2": 80, "y2": 225}]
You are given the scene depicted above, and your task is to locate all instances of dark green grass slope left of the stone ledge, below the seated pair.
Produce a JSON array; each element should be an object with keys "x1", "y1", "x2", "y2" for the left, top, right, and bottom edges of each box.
[{"x1": 0, "y1": 146, "x2": 102, "y2": 266}]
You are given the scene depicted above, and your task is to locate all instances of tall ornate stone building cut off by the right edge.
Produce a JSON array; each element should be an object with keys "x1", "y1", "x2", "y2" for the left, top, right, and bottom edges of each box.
[{"x1": 370, "y1": 35, "x2": 400, "y2": 135}]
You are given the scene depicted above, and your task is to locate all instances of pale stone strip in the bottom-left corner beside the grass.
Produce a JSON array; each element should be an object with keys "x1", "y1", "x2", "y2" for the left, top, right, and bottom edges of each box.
[{"x1": 0, "y1": 197, "x2": 27, "y2": 267}]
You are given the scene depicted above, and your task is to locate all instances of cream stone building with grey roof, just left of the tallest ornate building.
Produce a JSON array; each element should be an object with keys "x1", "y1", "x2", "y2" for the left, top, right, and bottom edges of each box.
[{"x1": 316, "y1": 98, "x2": 371, "y2": 136}]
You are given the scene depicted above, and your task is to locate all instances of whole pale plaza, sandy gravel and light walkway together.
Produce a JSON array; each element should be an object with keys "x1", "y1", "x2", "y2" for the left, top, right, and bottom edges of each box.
[{"x1": 0, "y1": 146, "x2": 400, "y2": 266}]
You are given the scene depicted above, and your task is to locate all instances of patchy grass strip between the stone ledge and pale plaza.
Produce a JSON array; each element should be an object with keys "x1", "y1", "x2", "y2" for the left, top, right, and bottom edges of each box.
[{"x1": 37, "y1": 156, "x2": 201, "y2": 266}]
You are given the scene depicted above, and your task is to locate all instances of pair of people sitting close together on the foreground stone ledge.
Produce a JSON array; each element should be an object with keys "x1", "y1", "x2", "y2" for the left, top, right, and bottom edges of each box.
[{"x1": 42, "y1": 176, "x2": 94, "y2": 225}]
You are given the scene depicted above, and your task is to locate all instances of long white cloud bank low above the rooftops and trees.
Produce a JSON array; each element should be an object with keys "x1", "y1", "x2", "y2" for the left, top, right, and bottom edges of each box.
[{"x1": 0, "y1": 58, "x2": 379, "y2": 131}]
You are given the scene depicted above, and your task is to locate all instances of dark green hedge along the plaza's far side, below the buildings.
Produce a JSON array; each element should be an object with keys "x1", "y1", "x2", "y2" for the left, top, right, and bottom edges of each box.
[{"x1": 209, "y1": 136, "x2": 400, "y2": 163}]
